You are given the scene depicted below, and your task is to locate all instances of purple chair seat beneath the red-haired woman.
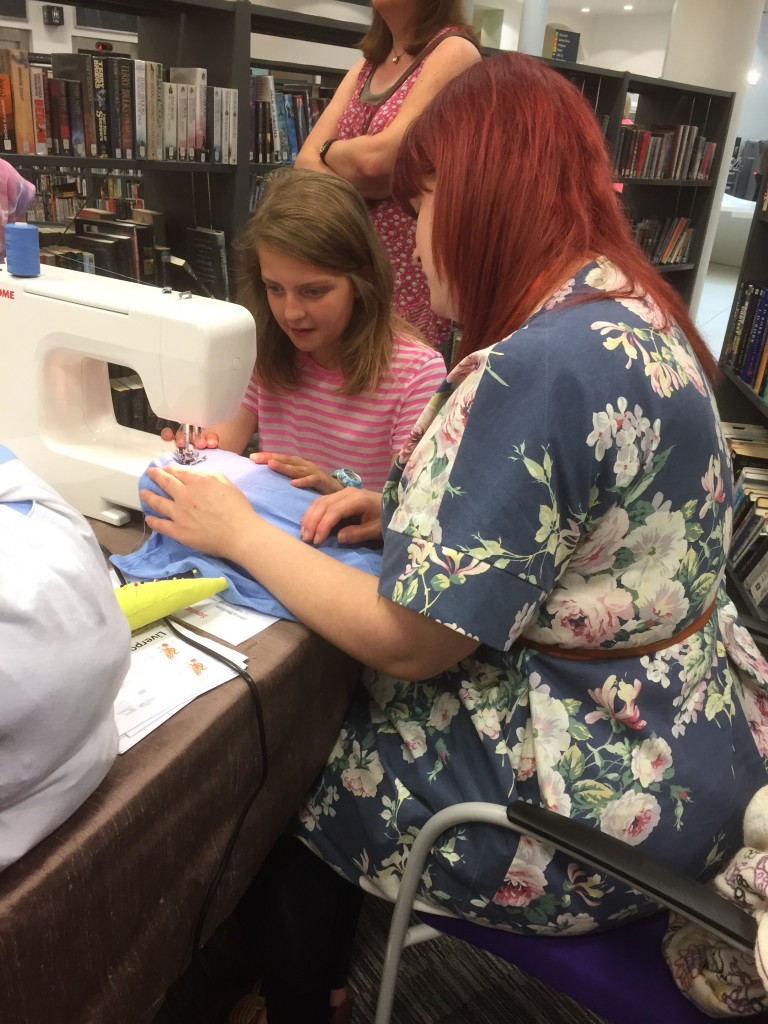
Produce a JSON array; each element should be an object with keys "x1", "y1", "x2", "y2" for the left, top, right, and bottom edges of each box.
[{"x1": 418, "y1": 912, "x2": 768, "y2": 1024}]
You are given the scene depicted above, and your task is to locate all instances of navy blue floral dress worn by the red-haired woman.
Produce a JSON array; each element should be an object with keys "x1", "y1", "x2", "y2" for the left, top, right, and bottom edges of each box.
[{"x1": 296, "y1": 260, "x2": 768, "y2": 934}]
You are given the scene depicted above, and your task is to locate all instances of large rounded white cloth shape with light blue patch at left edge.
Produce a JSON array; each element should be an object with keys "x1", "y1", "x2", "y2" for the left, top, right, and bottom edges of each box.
[{"x1": 0, "y1": 445, "x2": 130, "y2": 870}]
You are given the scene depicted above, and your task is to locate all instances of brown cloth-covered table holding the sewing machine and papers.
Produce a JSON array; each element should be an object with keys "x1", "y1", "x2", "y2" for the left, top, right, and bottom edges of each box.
[{"x1": 0, "y1": 523, "x2": 359, "y2": 1024}]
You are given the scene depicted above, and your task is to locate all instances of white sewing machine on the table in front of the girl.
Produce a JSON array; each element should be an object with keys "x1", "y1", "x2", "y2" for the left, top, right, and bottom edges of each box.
[{"x1": 0, "y1": 266, "x2": 256, "y2": 525}]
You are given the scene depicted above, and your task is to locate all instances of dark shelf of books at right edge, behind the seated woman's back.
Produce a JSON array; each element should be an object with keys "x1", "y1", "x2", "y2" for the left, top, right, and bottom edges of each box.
[{"x1": 720, "y1": 178, "x2": 768, "y2": 635}]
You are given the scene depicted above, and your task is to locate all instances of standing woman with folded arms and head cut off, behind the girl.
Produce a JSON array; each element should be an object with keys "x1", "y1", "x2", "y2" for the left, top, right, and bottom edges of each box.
[{"x1": 296, "y1": 0, "x2": 480, "y2": 354}]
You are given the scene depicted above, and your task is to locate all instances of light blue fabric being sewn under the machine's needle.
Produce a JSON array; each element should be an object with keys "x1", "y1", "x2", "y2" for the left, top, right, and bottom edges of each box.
[{"x1": 112, "y1": 449, "x2": 381, "y2": 622}]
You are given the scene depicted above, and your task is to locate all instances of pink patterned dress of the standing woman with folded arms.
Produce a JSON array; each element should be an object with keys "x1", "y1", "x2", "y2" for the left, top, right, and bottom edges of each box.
[{"x1": 337, "y1": 27, "x2": 466, "y2": 346}]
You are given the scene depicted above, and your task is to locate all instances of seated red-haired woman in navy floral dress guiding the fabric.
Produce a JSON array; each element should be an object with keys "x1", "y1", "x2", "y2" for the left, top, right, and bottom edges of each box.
[{"x1": 140, "y1": 53, "x2": 768, "y2": 1024}]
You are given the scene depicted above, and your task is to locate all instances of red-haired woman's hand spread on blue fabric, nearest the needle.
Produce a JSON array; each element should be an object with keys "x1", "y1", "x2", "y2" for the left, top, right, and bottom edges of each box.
[{"x1": 139, "y1": 465, "x2": 257, "y2": 563}]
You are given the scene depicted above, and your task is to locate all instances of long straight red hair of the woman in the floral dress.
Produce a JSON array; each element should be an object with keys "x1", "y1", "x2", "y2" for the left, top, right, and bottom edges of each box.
[{"x1": 393, "y1": 53, "x2": 718, "y2": 379}]
